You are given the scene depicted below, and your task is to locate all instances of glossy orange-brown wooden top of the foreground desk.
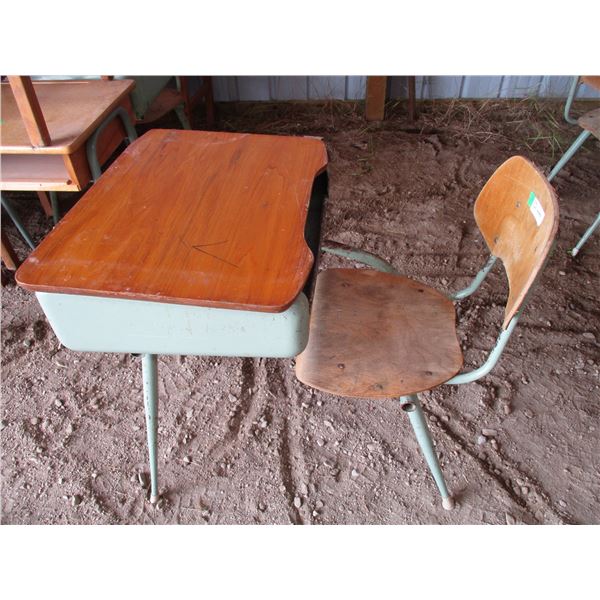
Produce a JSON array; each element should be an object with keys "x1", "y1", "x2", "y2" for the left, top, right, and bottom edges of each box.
[{"x1": 16, "y1": 129, "x2": 327, "y2": 312}]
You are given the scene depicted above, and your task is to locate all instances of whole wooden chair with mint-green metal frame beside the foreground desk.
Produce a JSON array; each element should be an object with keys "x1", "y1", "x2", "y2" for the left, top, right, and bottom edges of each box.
[{"x1": 296, "y1": 156, "x2": 558, "y2": 509}]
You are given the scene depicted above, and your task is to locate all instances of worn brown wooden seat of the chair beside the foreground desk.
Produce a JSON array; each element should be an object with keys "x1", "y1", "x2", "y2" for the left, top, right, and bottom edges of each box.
[{"x1": 296, "y1": 269, "x2": 463, "y2": 398}]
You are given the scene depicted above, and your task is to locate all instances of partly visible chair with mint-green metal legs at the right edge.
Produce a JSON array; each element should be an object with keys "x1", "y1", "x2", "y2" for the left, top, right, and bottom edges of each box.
[{"x1": 548, "y1": 76, "x2": 600, "y2": 256}]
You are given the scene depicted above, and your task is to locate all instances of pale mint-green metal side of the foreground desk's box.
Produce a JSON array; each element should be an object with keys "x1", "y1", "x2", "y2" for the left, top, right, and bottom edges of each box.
[{"x1": 36, "y1": 292, "x2": 309, "y2": 358}]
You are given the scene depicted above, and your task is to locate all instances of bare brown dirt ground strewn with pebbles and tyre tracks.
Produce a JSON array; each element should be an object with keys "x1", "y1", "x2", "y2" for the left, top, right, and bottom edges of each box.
[{"x1": 0, "y1": 100, "x2": 600, "y2": 524}]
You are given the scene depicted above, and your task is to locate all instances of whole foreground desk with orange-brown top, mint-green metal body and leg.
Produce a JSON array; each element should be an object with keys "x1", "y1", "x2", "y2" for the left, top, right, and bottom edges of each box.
[{"x1": 16, "y1": 130, "x2": 327, "y2": 501}]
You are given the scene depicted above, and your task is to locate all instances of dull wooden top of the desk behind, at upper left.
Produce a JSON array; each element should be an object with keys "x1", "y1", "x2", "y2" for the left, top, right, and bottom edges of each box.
[{"x1": 0, "y1": 79, "x2": 135, "y2": 154}]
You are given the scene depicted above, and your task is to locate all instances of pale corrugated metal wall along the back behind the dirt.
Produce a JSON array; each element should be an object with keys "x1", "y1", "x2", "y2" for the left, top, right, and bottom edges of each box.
[{"x1": 213, "y1": 75, "x2": 600, "y2": 102}]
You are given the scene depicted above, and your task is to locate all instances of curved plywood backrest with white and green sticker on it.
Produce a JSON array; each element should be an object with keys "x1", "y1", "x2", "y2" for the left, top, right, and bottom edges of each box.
[{"x1": 475, "y1": 156, "x2": 558, "y2": 329}]
